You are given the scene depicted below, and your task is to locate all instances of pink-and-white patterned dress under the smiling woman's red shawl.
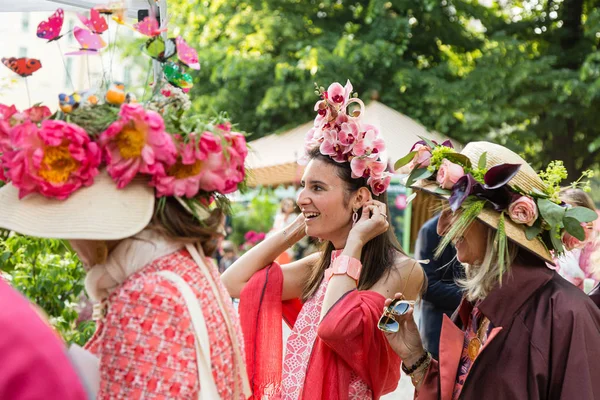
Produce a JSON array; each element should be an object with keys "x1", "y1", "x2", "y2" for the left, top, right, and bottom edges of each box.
[{"x1": 282, "y1": 252, "x2": 373, "y2": 400}]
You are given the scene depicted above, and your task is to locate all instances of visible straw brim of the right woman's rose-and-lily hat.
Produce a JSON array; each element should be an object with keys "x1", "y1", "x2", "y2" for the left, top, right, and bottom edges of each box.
[{"x1": 411, "y1": 180, "x2": 554, "y2": 265}]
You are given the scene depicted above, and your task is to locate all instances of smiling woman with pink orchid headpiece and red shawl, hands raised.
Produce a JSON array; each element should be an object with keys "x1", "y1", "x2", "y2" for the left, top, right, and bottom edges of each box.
[{"x1": 222, "y1": 82, "x2": 424, "y2": 400}]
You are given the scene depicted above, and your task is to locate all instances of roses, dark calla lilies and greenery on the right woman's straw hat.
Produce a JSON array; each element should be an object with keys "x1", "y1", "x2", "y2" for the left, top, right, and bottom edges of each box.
[{"x1": 395, "y1": 138, "x2": 598, "y2": 272}]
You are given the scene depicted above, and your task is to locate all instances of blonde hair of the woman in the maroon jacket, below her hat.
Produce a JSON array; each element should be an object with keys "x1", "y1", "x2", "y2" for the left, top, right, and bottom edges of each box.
[{"x1": 456, "y1": 227, "x2": 519, "y2": 301}]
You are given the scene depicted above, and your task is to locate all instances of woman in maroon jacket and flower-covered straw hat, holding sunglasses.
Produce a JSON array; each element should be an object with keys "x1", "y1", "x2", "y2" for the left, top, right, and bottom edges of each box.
[{"x1": 379, "y1": 141, "x2": 600, "y2": 400}]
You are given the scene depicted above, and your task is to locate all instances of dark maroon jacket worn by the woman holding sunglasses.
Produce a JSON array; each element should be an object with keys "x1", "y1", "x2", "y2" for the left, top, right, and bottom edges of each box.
[{"x1": 417, "y1": 253, "x2": 600, "y2": 400}]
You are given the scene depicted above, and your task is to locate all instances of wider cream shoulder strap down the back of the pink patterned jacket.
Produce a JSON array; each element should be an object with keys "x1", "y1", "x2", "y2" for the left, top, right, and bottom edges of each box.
[{"x1": 157, "y1": 271, "x2": 220, "y2": 400}]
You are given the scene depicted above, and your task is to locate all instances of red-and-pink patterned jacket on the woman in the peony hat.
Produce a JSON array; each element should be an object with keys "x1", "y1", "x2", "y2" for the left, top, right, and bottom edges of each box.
[{"x1": 86, "y1": 250, "x2": 243, "y2": 400}]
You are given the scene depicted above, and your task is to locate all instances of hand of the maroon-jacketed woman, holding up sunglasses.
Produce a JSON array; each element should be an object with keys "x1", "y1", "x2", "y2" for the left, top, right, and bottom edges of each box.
[{"x1": 384, "y1": 293, "x2": 425, "y2": 367}]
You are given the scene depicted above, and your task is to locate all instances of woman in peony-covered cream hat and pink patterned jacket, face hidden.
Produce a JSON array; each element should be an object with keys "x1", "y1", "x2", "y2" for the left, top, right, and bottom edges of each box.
[{"x1": 0, "y1": 88, "x2": 250, "y2": 400}]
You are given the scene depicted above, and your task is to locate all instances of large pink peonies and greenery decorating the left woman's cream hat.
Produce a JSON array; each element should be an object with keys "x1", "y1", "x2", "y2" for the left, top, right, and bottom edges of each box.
[{"x1": 0, "y1": 7, "x2": 248, "y2": 219}]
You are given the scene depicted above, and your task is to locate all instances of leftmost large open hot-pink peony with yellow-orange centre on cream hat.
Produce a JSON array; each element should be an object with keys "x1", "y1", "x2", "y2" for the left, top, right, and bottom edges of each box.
[{"x1": 3, "y1": 120, "x2": 101, "y2": 200}]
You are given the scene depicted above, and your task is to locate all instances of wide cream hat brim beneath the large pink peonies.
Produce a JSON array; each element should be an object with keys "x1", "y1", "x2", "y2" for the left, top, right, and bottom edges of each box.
[{"x1": 0, "y1": 171, "x2": 155, "y2": 240}]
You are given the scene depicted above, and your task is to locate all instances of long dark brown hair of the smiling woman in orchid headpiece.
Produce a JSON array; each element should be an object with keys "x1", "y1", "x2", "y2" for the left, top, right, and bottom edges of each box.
[{"x1": 302, "y1": 147, "x2": 406, "y2": 301}]
